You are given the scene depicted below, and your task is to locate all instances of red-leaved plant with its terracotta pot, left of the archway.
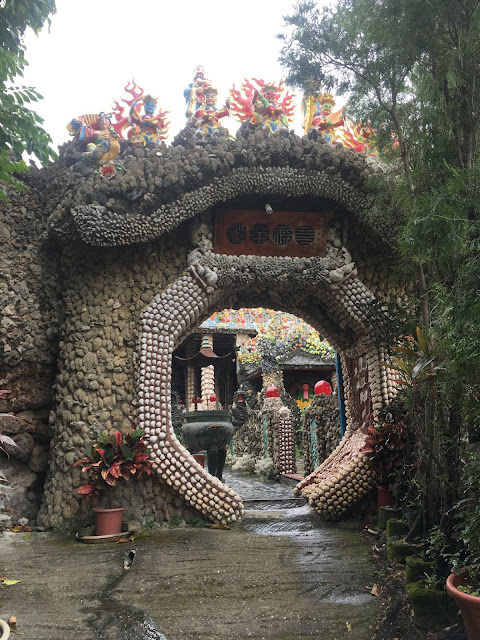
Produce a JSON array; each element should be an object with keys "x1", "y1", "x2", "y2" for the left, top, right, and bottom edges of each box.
[{"x1": 73, "y1": 429, "x2": 152, "y2": 536}]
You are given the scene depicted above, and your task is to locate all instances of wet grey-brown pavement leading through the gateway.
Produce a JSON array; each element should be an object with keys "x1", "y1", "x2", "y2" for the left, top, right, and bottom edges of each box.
[{"x1": 0, "y1": 471, "x2": 380, "y2": 640}]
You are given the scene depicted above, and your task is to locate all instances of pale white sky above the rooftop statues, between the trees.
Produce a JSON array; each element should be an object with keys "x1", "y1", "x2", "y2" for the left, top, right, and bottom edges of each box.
[{"x1": 23, "y1": 0, "x2": 324, "y2": 148}]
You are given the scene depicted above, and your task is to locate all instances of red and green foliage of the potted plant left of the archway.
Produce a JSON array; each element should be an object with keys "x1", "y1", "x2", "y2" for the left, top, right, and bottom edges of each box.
[{"x1": 73, "y1": 429, "x2": 152, "y2": 502}]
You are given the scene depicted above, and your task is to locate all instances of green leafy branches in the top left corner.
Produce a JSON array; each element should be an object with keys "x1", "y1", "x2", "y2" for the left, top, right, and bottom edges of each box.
[{"x1": 0, "y1": 0, "x2": 55, "y2": 200}]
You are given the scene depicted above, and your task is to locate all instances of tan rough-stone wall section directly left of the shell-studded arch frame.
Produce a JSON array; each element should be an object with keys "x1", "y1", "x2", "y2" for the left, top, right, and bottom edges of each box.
[{"x1": 38, "y1": 232, "x2": 194, "y2": 527}]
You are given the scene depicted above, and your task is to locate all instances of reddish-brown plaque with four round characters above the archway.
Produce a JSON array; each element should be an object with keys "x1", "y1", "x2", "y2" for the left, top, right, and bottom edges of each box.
[{"x1": 214, "y1": 209, "x2": 328, "y2": 258}]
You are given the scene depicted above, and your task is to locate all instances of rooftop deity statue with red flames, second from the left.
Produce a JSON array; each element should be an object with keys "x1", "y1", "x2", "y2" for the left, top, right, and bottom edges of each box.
[{"x1": 113, "y1": 80, "x2": 170, "y2": 145}]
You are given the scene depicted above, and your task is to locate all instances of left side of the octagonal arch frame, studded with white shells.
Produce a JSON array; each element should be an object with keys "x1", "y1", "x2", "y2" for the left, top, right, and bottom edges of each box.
[{"x1": 138, "y1": 270, "x2": 243, "y2": 524}]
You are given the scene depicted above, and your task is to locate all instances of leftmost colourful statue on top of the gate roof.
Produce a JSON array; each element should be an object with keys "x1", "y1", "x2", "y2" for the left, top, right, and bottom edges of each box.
[{"x1": 67, "y1": 112, "x2": 120, "y2": 167}]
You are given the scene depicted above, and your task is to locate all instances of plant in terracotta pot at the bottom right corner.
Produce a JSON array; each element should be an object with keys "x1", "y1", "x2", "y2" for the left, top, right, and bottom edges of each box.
[{"x1": 446, "y1": 453, "x2": 480, "y2": 640}]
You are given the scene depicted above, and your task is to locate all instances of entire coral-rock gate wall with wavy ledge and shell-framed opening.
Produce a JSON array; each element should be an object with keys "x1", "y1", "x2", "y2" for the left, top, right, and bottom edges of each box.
[{"x1": 0, "y1": 131, "x2": 408, "y2": 526}]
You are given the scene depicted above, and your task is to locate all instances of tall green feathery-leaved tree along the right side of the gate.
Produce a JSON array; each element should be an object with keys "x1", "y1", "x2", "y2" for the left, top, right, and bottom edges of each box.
[{"x1": 280, "y1": 0, "x2": 480, "y2": 544}]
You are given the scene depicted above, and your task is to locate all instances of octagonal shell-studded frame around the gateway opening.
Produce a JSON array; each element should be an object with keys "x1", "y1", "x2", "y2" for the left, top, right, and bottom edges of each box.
[{"x1": 138, "y1": 251, "x2": 394, "y2": 524}]
